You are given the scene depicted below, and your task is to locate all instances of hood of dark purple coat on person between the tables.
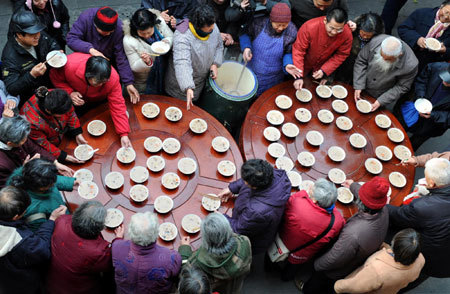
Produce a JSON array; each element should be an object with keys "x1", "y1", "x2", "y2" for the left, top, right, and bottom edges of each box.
[{"x1": 250, "y1": 169, "x2": 292, "y2": 206}]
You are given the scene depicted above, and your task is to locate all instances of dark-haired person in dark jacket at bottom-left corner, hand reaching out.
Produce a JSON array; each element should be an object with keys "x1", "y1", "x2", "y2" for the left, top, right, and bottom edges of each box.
[{"x1": 0, "y1": 186, "x2": 65, "y2": 294}]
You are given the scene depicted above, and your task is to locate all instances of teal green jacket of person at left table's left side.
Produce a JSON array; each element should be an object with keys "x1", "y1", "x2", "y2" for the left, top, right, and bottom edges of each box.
[{"x1": 6, "y1": 167, "x2": 75, "y2": 231}]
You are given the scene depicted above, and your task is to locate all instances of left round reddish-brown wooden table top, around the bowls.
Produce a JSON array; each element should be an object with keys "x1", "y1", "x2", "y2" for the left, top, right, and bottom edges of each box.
[{"x1": 60, "y1": 95, "x2": 242, "y2": 248}]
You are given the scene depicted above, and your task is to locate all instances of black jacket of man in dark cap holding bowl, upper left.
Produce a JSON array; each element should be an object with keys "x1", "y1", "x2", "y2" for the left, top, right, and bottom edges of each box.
[{"x1": 2, "y1": 32, "x2": 61, "y2": 106}]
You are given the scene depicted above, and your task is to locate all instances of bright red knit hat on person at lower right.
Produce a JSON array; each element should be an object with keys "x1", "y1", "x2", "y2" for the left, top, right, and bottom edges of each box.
[{"x1": 358, "y1": 177, "x2": 389, "y2": 209}]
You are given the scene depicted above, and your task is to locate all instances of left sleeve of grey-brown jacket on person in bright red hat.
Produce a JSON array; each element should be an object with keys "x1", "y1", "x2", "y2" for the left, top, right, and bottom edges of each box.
[{"x1": 314, "y1": 231, "x2": 357, "y2": 271}]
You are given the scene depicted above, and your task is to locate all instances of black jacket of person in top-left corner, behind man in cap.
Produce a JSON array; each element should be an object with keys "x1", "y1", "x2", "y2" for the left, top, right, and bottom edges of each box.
[{"x1": 18, "y1": 0, "x2": 70, "y2": 49}]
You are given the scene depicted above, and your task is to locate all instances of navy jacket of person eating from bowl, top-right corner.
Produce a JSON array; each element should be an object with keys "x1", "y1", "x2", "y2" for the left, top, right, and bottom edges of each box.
[{"x1": 397, "y1": 7, "x2": 450, "y2": 60}]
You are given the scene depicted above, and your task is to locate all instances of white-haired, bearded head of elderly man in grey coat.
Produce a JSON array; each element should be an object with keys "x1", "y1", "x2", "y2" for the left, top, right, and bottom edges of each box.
[{"x1": 373, "y1": 36, "x2": 403, "y2": 73}]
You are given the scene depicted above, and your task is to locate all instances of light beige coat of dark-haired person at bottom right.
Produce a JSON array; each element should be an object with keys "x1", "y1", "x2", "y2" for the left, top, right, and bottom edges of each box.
[{"x1": 334, "y1": 248, "x2": 425, "y2": 294}]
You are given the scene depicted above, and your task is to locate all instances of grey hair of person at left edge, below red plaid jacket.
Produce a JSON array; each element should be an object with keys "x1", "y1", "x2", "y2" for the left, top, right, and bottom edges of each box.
[{"x1": 0, "y1": 116, "x2": 31, "y2": 144}]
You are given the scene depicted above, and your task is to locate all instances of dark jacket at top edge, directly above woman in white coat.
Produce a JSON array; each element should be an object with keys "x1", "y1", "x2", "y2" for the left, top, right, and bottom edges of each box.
[{"x1": 141, "y1": 0, "x2": 197, "y2": 20}]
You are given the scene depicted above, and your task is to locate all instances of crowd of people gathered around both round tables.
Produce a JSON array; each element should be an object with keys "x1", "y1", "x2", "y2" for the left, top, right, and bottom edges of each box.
[{"x1": 0, "y1": 0, "x2": 450, "y2": 294}]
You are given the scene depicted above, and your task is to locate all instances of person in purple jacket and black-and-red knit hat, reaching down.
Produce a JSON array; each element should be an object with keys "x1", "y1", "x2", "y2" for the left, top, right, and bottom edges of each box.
[{"x1": 67, "y1": 6, "x2": 140, "y2": 103}]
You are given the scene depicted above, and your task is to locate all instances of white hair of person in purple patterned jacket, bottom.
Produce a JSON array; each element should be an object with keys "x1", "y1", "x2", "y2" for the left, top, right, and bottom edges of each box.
[{"x1": 128, "y1": 211, "x2": 159, "y2": 246}]
